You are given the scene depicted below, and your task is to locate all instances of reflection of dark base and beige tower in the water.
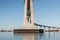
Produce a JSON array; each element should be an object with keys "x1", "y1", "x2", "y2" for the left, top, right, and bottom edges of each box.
[{"x1": 14, "y1": 33, "x2": 44, "y2": 40}]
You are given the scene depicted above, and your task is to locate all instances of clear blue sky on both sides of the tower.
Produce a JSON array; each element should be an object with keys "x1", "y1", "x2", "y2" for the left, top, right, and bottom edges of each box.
[{"x1": 0, "y1": 0, "x2": 60, "y2": 29}]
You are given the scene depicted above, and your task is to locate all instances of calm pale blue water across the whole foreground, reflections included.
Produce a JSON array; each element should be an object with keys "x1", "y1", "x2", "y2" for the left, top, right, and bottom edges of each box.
[{"x1": 0, "y1": 32, "x2": 60, "y2": 40}]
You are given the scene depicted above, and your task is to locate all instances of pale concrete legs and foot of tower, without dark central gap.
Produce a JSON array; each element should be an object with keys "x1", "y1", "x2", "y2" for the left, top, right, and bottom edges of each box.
[{"x1": 23, "y1": 0, "x2": 35, "y2": 29}]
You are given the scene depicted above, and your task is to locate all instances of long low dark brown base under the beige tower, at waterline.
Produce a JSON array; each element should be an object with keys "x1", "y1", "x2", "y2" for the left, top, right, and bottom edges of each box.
[{"x1": 14, "y1": 29, "x2": 44, "y2": 33}]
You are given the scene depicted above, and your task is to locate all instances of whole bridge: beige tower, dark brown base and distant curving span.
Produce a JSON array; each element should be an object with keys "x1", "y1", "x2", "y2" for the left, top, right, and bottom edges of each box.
[{"x1": 14, "y1": 0, "x2": 60, "y2": 32}]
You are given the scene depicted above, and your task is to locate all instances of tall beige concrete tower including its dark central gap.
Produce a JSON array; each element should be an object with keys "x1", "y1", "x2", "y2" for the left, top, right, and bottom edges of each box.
[{"x1": 24, "y1": 0, "x2": 35, "y2": 29}]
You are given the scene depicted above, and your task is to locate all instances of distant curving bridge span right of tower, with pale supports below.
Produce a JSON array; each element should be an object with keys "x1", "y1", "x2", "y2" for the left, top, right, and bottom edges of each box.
[{"x1": 34, "y1": 23, "x2": 60, "y2": 32}]
